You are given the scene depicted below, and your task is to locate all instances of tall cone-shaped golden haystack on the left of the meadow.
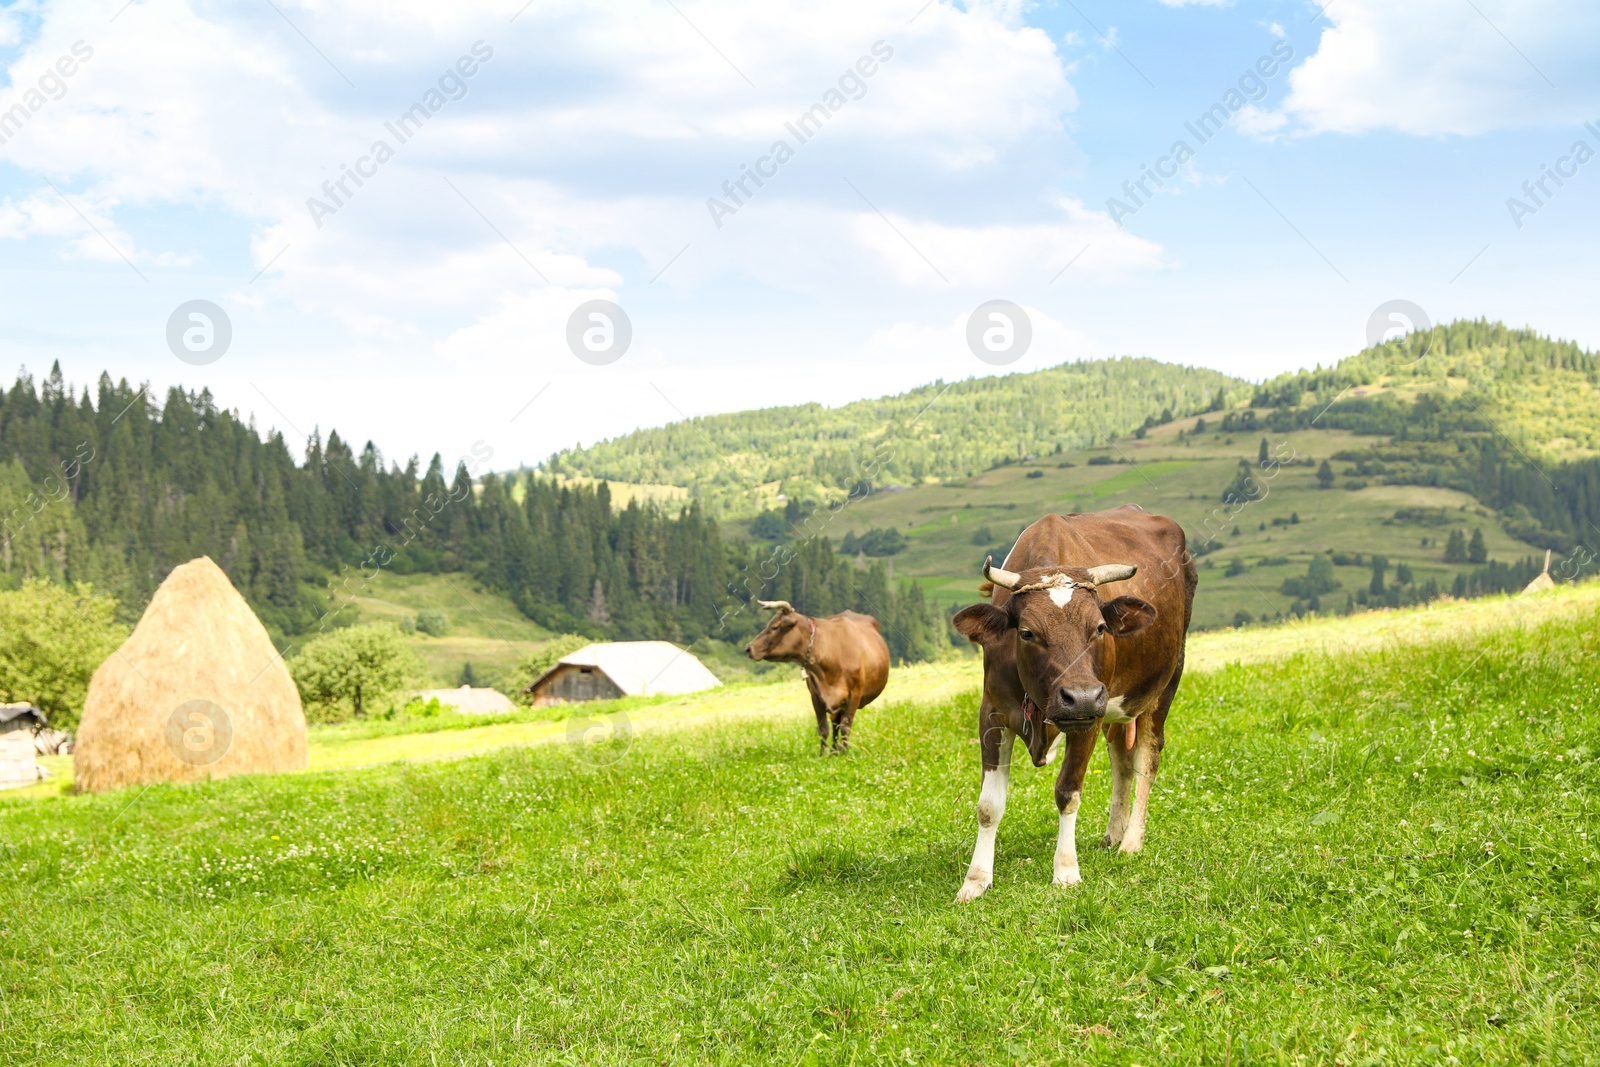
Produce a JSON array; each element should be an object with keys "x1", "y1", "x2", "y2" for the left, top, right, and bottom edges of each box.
[{"x1": 74, "y1": 557, "x2": 306, "y2": 792}]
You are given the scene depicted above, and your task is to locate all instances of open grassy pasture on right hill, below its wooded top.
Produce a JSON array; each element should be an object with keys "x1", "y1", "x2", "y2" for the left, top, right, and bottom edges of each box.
[{"x1": 806, "y1": 416, "x2": 1542, "y2": 629}]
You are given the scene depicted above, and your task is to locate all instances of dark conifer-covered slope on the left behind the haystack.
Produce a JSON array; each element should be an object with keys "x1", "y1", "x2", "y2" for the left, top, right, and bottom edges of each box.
[{"x1": 0, "y1": 366, "x2": 946, "y2": 659}]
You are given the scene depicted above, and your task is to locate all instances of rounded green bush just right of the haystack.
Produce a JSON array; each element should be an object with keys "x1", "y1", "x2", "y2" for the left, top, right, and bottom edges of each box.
[{"x1": 290, "y1": 622, "x2": 424, "y2": 723}]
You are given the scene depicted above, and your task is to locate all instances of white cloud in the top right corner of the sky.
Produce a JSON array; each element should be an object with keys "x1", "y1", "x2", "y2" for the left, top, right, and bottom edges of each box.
[{"x1": 1282, "y1": 0, "x2": 1600, "y2": 136}]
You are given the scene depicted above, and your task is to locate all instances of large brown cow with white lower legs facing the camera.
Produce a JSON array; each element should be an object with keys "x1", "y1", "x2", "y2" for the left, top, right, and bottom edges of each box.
[{"x1": 952, "y1": 506, "x2": 1197, "y2": 901}]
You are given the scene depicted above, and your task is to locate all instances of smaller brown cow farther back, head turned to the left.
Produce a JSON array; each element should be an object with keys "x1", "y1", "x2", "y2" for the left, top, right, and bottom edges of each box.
[{"x1": 744, "y1": 600, "x2": 890, "y2": 755}]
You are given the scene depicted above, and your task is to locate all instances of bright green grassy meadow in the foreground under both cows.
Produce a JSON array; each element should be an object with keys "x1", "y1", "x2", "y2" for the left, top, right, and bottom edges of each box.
[{"x1": 0, "y1": 598, "x2": 1600, "y2": 1064}]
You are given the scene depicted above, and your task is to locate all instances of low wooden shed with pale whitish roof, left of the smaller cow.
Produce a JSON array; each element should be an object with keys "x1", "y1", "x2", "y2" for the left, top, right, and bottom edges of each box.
[{"x1": 523, "y1": 641, "x2": 722, "y2": 707}]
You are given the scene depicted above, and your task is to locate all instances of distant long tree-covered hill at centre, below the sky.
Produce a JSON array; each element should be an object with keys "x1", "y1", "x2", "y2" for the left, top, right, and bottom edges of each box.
[{"x1": 547, "y1": 357, "x2": 1253, "y2": 514}]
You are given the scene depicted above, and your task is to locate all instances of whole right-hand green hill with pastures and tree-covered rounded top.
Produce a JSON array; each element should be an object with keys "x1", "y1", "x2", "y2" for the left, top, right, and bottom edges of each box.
[{"x1": 723, "y1": 323, "x2": 1600, "y2": 627}]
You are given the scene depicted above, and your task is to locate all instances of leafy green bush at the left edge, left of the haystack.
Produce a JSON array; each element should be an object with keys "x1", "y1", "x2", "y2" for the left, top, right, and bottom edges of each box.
[{"x1": 0, "y1": 579, "x2": 128, "y2": 729}]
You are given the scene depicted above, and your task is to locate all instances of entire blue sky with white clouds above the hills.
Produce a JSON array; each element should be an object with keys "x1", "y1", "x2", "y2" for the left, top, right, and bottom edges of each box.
[{"x1": 0, "y1": 0, "x2": 1600, "y2": 467}]
